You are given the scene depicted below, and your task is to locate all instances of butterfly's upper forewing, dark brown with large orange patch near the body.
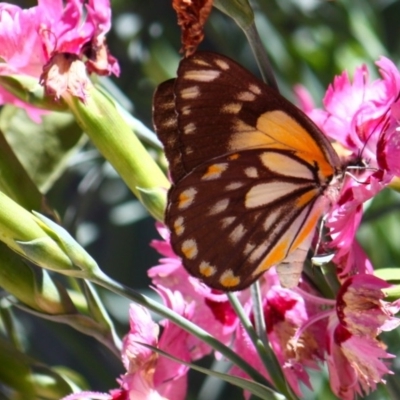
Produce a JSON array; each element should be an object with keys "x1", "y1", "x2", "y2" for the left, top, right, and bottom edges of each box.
[{"x1": 174, "y1": 53, "x2": 339, "y2": 175}]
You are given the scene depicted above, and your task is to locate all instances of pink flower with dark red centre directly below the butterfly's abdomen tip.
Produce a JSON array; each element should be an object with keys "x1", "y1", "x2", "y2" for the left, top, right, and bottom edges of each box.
[{"x1": 231, "y1": 270, "x2": 330, "y2": 396}]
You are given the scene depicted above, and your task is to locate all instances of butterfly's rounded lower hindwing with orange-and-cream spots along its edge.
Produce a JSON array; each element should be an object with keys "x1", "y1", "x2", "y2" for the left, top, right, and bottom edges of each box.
[{"x1": 166, "y1": 150, "x2": 330, "y2": 290}]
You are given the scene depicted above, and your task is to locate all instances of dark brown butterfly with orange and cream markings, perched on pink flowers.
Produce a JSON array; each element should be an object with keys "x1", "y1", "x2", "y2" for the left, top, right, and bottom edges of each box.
[{"x1": 153, "y1": 52, "x2": 343, "y2": 291}]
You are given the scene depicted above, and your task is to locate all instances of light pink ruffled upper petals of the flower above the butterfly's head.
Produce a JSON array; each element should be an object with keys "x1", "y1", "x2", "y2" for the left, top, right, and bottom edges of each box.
[{"x1": 310, "y1": 57, "x2": 400, "y2": 166}]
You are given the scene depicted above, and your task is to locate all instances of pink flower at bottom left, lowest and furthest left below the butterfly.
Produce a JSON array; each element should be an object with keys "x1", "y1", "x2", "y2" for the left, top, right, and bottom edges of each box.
[{"x1": 62, "y1": 289, "x2": 193, "y2": 400}]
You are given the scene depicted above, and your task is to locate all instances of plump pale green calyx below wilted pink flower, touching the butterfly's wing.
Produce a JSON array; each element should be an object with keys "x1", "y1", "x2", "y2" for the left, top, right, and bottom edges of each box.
[{"x1": 64, "y1": 84, "x2": 170, "y2": 219}]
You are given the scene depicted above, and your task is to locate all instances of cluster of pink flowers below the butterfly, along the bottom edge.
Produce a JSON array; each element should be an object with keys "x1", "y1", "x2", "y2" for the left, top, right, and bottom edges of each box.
[{"x1": 68, "y1": 219, "x2": 400, "y2": 400}]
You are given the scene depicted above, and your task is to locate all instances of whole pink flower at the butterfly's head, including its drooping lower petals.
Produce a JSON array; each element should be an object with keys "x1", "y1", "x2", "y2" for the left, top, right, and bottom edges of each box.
[{"x1": 297, "y1": 57, "x2": 400, "y2": 275}]
